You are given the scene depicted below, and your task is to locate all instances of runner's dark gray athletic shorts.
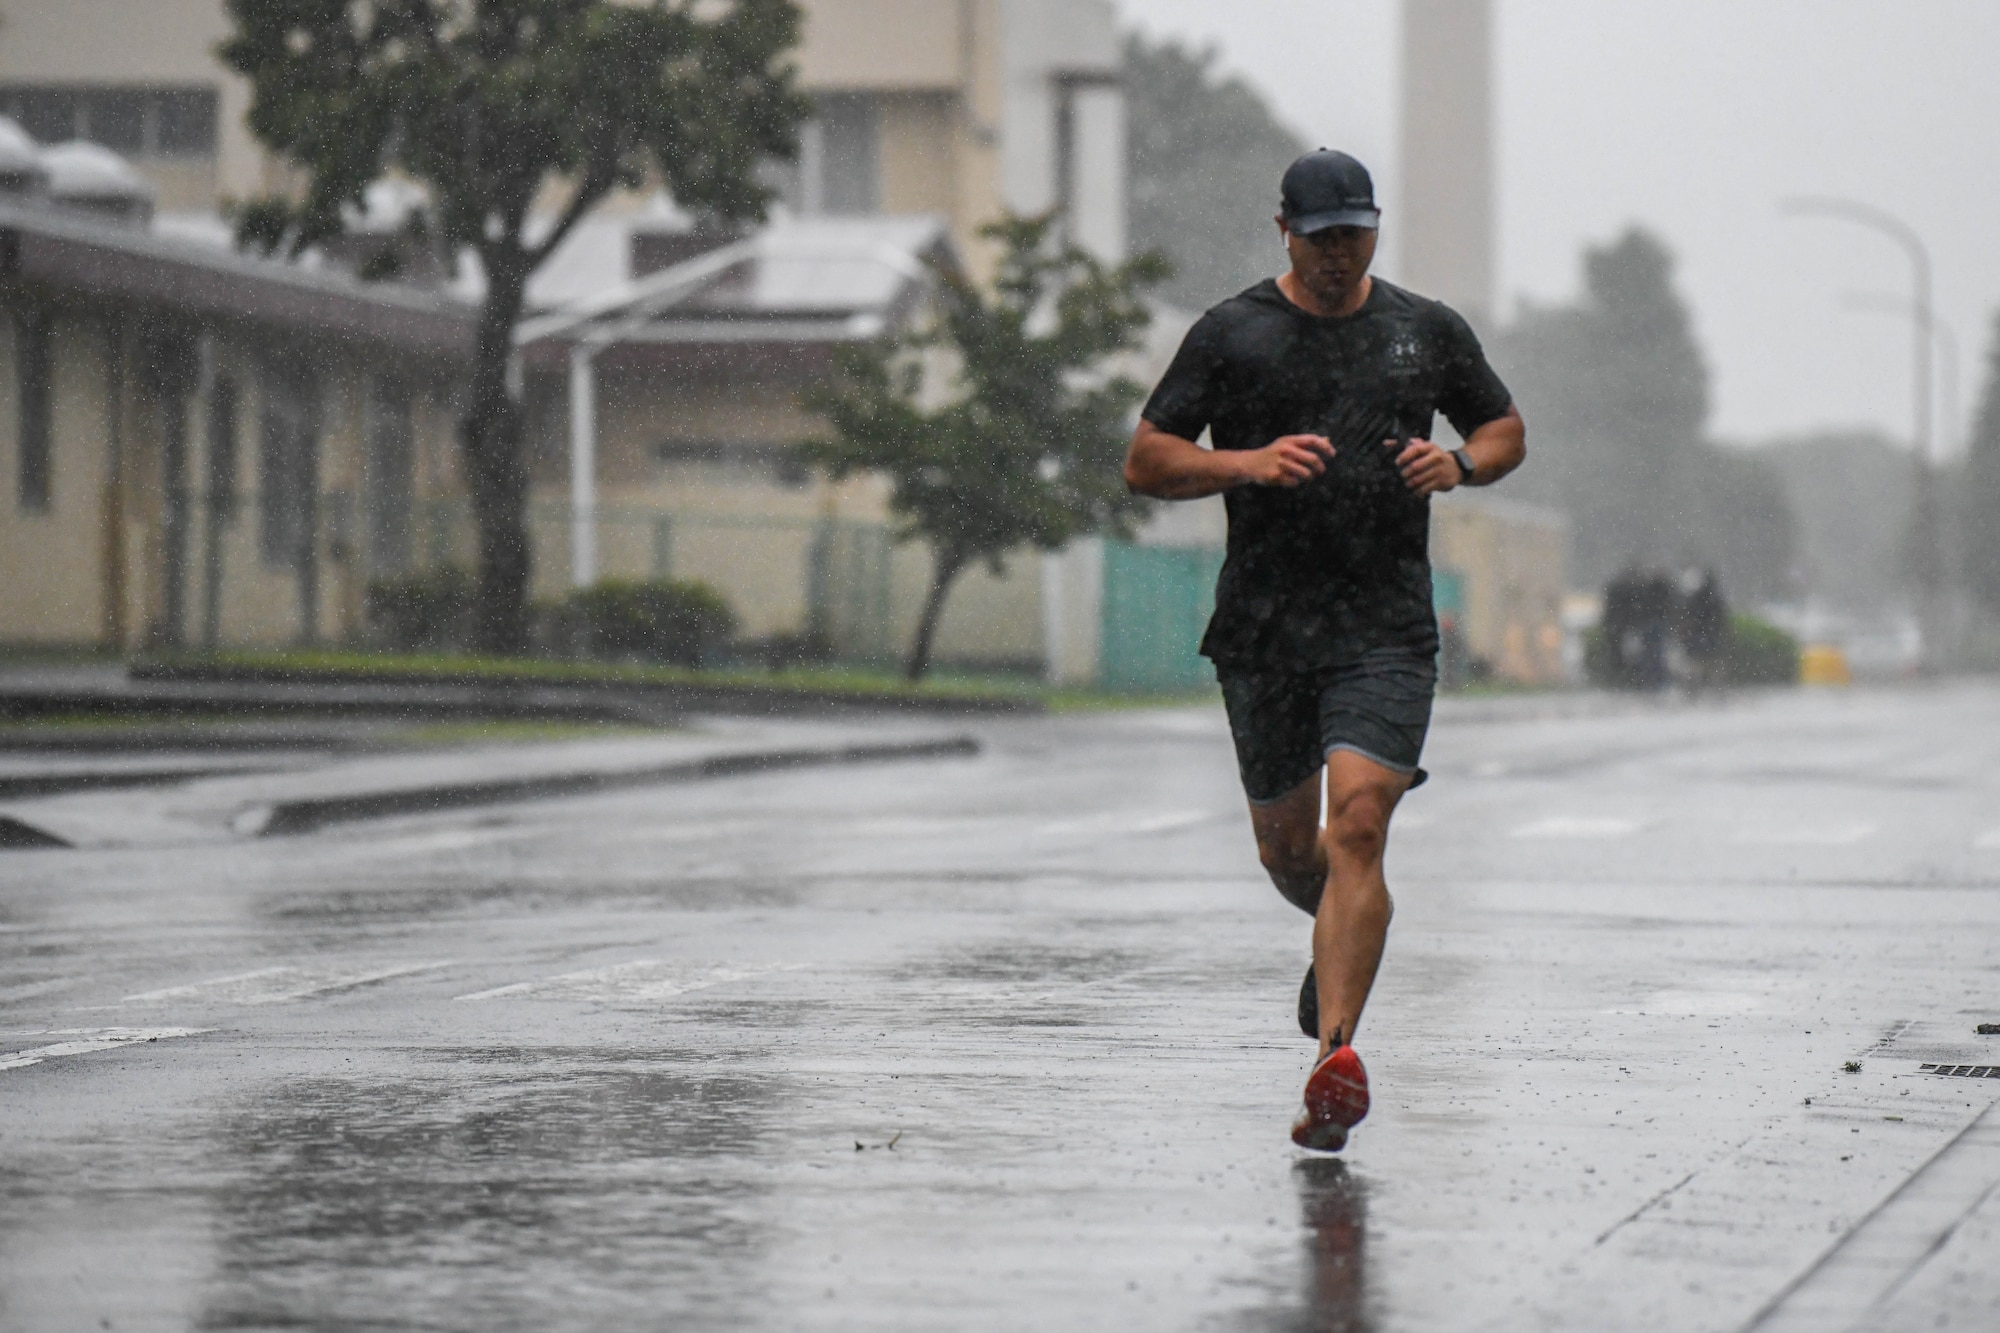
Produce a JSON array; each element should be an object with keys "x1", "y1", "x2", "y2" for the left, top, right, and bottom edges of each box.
[{"x1": 1216, "y1": 648, "x2": 1438, "y2": 805}]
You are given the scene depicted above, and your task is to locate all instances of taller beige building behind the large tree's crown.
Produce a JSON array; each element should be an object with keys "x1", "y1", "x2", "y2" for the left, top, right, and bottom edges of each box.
[{"x1": 0, "y1": 0, "x2": 1124, "y2": 264}]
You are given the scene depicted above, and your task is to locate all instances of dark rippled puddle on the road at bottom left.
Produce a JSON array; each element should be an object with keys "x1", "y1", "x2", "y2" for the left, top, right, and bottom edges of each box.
[{"x1": 186, "y1": 1051, "x2": 784, "y2": 1329}]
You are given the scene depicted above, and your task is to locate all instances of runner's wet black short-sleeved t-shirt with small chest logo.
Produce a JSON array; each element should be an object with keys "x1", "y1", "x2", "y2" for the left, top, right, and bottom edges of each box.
[{"x1": 1142, "y1": 278, "x2": 1512, "y2": 671}]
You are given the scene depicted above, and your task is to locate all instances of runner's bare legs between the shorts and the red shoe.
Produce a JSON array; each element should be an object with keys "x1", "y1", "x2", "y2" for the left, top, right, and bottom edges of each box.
[{"x1": 1250, "y1": 751, "x2": 1410, "y2": 1057}]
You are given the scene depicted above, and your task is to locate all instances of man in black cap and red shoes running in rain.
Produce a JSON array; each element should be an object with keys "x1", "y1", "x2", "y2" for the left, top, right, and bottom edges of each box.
[{"x1": 1126, "y1": 148, "x2": 1526, "y2": 1151}]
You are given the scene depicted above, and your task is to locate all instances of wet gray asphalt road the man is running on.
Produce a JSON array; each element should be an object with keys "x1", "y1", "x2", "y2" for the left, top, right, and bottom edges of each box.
[{"x1": 0, "y1": 687, "x2": 2000, "y2": 1331}]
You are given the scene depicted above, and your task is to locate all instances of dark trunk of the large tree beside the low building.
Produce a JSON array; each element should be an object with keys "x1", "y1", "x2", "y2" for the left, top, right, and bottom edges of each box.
[{"x1": 458, "y1": 256, "x2": 530, "y2": 656}]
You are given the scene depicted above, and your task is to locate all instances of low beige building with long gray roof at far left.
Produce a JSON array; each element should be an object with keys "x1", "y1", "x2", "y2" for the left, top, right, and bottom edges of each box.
[{"x1": 0, "y1": 198, "x2": 472, "y2": 648}]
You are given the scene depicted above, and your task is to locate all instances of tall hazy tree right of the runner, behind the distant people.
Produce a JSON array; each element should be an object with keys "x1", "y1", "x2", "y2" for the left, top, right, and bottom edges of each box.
[{"x1": 1494, "y1": 228, "x2": 1796, "y2": 600}]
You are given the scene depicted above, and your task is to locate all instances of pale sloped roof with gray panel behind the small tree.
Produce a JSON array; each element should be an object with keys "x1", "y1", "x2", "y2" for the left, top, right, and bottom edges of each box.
[{"x1": 518, "y1": 216, "x2": 956, "y2": 354}]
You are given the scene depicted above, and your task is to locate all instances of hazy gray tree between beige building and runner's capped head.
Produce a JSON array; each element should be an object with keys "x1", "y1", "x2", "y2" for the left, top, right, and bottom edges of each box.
[{"x1": 1124, "y1": 34, "x2": 1306, "y2": 310}]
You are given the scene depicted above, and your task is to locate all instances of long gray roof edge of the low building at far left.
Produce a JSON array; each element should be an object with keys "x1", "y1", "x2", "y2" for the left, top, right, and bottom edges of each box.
[{"x1": 0, "y1": 200, "x2": 478, "y2": 358}]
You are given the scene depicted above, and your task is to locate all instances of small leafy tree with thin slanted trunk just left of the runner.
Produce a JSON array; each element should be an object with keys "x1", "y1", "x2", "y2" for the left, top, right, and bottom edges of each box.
[{"x1": 804, "y1": 214, "x2": 1168, "y2": 681}]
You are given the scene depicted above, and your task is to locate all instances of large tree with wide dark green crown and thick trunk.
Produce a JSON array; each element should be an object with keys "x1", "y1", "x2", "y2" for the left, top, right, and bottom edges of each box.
[{"x1": 220, "y1": 0, "x2": 808, "y2": 652}]
